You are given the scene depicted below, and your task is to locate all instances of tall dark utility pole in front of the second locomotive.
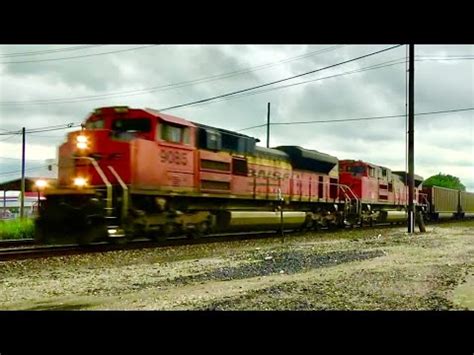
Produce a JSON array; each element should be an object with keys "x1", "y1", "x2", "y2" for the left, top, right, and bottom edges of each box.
[{"x1": 408, "y1": 44, "x2": 415, "y2": 234}]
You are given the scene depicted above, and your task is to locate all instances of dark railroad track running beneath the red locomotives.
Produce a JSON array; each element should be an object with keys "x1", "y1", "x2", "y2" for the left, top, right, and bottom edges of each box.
[{"x1": 0, "y1": 221, "x2": 466, "y2": 261}]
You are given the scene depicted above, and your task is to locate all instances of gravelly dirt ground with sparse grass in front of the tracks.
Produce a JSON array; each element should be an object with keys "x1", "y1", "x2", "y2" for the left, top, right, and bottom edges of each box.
[{"x1": 0, "y1": 221, "x2": 474, "y2": 310}]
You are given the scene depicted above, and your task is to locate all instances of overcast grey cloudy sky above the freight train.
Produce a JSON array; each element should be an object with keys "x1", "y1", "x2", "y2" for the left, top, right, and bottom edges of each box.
[{"x1": 0, "y1": 44, "x2": 474, "y2": 191}]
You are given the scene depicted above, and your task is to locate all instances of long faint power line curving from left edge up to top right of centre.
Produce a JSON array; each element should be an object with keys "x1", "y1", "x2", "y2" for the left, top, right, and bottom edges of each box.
[{"x1": 0, "y1": 45, "x2": 344, "y2": 105}]
